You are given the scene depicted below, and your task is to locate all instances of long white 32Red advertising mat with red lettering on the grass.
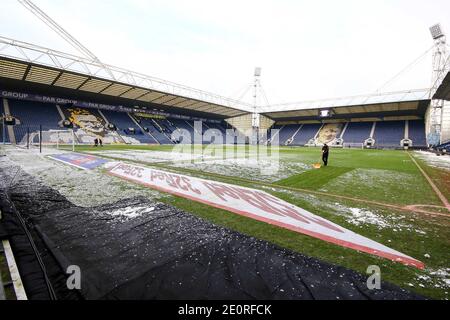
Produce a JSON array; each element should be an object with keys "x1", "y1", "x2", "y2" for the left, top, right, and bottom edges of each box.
[{"x1": 108, "y1": 163, "x2": 424, "y2": 269}]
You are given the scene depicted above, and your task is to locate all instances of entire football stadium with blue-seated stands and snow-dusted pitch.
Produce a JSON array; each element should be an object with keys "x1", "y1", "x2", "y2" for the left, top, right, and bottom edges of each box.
[{"x1": 0, "y1": 0, "x2": 450, "y2": 304}]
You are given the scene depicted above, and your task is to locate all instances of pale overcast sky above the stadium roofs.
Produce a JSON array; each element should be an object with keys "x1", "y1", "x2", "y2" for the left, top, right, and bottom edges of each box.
[{"x1": 0, "y1": 0, "x2": 450, "y2": 104}]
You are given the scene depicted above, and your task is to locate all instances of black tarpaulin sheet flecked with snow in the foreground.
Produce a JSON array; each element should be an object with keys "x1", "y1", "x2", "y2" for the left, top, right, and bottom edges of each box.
[{"x1": 37, "y1": 198, "x2": 426, "y2": 299}]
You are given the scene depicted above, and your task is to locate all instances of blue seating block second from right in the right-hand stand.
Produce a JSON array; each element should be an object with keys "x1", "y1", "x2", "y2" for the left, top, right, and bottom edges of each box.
[{"x1": 373, "y1": 121, "x2": 405, "y2": 148}]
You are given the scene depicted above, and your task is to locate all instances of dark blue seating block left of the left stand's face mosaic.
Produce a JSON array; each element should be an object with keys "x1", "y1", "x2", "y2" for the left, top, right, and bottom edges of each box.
[{"x1": 8, "y1": 100, "x2": 62, "y2": 142}]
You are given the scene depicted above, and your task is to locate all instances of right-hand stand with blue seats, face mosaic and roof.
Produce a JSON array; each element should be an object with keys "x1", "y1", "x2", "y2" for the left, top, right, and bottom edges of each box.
[{"x1": 264, "y1": 97, "x2": 430, "y2": 149}]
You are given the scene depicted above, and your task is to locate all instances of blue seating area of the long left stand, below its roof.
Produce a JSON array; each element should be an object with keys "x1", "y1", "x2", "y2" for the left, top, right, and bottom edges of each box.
[{"x1": 2, "y1": 99, "x2": 236, "y2": 145}]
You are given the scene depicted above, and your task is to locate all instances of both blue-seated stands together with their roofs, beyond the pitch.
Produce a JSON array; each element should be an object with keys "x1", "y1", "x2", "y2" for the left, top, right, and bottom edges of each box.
[{"x1": 0, "y1": 26, "x2": 450, "y2": 148}]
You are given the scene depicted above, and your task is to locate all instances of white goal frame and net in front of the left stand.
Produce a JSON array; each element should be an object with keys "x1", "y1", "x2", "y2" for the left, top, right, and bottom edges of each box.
[{"x1": 17, "y1": 129, "x2": 77, "y2": 151}]
